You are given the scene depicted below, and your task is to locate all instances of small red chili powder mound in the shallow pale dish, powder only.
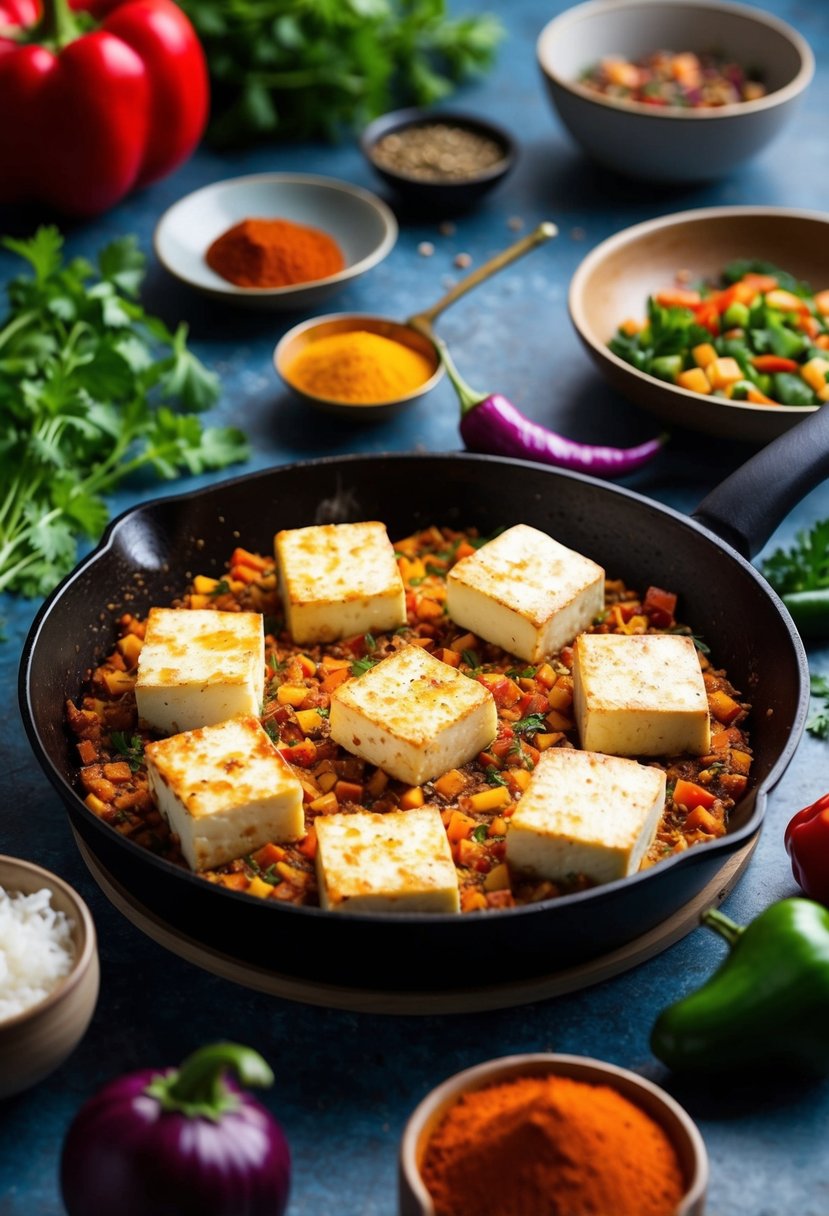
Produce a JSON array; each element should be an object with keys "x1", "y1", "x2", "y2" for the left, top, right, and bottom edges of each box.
[{"x1": 205, "y1": 219, "x2": 345, "y2": 287}]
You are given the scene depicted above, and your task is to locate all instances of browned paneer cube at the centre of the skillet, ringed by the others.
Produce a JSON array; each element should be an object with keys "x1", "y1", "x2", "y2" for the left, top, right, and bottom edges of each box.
[{"x1": 328, "y1": 646, "x2": 498, "y2": 786}]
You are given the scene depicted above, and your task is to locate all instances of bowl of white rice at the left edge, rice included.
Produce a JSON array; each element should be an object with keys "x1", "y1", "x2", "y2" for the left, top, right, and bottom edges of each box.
[{"x1": 0, "y1": 855, "x2": 100, "y2": 1098}]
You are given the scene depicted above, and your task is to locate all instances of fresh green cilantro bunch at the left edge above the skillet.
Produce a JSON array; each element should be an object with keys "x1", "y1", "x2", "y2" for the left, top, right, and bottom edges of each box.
[{"x1": 0, "y1": 227, "x2": 248, "y2": 596}]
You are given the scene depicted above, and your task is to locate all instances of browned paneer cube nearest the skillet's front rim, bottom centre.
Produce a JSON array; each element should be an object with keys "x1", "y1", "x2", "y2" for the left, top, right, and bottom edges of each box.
[{"x1": 316, "y1": 807, "x2": 459, "y2": 912}]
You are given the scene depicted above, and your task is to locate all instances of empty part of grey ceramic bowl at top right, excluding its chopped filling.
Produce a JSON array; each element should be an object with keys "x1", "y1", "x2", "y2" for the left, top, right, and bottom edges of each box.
[{"x1": 536, "y1": 0, "x2": 814, "y2": 182}]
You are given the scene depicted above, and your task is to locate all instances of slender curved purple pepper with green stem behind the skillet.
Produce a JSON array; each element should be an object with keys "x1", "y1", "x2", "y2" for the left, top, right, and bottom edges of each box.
[{"x1": 438, "y1": 342, "x2": 667, "y2": 477}]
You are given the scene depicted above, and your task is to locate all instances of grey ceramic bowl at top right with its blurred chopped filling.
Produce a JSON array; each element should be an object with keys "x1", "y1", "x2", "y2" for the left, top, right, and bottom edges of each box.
[{"x1": 537, "y1": 0, "x2": 814, "y2": 182}]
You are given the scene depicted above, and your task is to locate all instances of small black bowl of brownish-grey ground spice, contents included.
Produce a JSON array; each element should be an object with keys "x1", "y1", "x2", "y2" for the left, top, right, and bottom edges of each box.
[{"x1": 360, "y1": 108, "x2": 518, "y2": 214}]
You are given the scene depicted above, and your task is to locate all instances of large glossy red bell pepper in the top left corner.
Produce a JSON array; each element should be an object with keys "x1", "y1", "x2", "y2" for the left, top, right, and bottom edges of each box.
[{"x1": 0, "y1": 0, "x2": 209, "y2": 215}]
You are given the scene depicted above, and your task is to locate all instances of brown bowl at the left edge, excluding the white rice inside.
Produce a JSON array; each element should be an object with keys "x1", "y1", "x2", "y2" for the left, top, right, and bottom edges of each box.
[{"x1": 0, "y1": 856, "x2": 100, "y2": 1098}]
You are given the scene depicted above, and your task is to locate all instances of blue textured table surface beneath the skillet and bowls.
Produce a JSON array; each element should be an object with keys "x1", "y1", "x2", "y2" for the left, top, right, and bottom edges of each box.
[{"x1": 0, "y1": 0, "x2": 829, "y2": 1216}]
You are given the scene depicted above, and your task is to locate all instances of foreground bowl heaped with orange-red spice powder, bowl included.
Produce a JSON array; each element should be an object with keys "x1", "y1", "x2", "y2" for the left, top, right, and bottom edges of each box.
[{"x1": 399, "y1": 1053, "x2": 709, "y2": 1216}]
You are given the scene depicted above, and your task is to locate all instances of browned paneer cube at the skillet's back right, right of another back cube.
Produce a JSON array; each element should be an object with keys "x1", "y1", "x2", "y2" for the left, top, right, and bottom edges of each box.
[{"x1": 446, "y1": 524, "x2": 604, "y2": 663}]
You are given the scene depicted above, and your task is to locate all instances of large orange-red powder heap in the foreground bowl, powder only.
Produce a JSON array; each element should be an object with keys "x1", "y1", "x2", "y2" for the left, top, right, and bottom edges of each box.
[{"x1": 421, "y1": 1075, "x2": 686, "y2": 1216}]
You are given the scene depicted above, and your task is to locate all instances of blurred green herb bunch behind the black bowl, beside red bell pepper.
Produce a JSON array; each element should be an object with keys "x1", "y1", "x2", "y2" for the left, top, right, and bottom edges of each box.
[{"x1": 180, "y1": 0, "x2": 502, "y2": 146}]
